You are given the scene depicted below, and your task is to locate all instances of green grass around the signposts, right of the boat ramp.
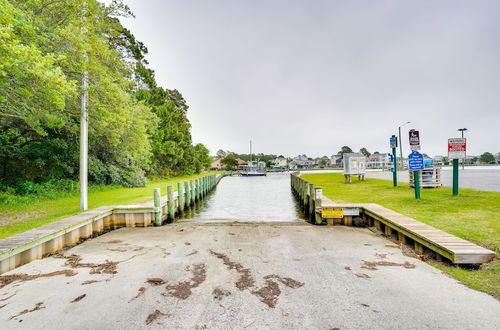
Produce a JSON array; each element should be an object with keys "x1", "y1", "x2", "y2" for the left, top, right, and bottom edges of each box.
[{"x1": 301, "y1": 173, "x2": 500, "y2": 298}]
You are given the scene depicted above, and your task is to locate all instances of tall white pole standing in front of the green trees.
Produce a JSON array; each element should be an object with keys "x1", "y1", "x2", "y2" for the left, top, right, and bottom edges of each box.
[{"x1": 80, "y1": 2, "x2": 88, "y2": 211}]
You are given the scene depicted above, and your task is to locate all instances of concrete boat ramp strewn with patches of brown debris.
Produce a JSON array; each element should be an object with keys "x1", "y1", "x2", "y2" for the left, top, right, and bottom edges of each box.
[{"x1": 0, "y1": 223, "x2": 500, "y2": 329}]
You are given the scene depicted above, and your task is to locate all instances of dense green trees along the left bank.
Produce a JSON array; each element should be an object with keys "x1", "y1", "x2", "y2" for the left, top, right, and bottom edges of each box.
[{"x1": 0, "y1": 0, "x2": 209, "y2": 193}]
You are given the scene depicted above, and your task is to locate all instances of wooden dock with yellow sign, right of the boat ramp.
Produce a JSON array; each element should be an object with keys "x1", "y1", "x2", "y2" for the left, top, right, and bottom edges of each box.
[{"x1": 292, "y1": 173, "x2": 496, "y2": 264}]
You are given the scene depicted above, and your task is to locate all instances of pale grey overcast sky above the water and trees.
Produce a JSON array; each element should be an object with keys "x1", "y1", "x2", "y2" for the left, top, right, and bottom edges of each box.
[{"x1": 116, "y1": 0, "x2": 500, "y2": 156}]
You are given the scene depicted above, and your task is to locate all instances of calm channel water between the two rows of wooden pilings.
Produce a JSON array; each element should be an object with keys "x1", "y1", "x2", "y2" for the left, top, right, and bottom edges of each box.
[{"x1": 180, "y1": 173, "x2": 304, "y2": 222}]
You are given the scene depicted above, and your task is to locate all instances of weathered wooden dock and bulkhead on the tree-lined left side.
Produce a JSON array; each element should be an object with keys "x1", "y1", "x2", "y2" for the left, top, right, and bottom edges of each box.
[{"x1": 0, "y1": 174, "x2": 224, "y2": 274}]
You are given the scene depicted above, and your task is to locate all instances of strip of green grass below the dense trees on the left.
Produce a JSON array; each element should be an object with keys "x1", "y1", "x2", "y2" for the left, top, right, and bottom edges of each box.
[{"x1": 0, "y1": 173, "x2": 217, "y2": 239}]
